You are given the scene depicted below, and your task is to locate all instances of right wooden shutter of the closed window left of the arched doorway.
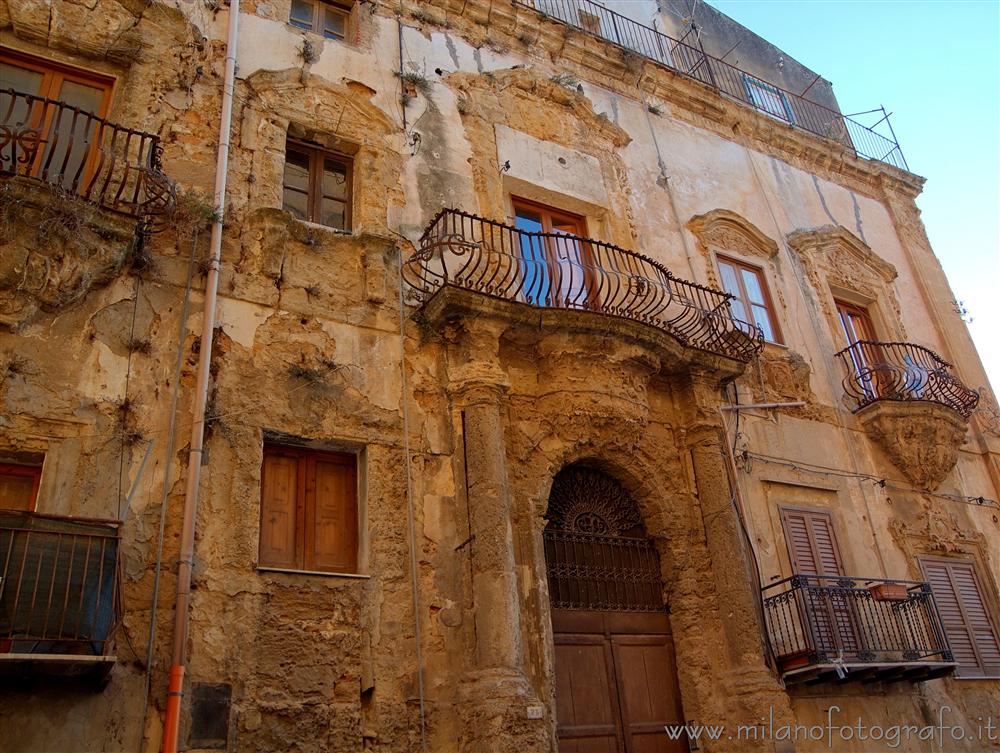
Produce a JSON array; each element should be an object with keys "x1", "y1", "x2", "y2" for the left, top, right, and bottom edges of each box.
[{"x1": 306, "y1": 455, "x2": 358, "y2": 572}]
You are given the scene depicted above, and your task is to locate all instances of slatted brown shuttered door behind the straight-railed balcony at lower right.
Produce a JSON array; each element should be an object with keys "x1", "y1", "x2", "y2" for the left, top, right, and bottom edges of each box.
[{"x1": 781, "y1": 507, "x2": 862, "y2": 658}]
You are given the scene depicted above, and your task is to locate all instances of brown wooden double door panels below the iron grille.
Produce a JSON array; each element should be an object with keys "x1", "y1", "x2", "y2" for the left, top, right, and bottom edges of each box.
[{"x1": 552, "y1": 609, "x2": 687, "y2": 753}]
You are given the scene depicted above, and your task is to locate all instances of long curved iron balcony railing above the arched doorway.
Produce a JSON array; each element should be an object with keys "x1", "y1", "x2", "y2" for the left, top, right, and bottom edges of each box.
[{"x1": 403, "y1": 209, "x2": 764, "y2": 363}]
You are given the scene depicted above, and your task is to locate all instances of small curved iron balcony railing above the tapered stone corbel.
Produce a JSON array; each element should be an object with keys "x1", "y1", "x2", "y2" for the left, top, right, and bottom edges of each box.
[{"x1": 837, "y1": 340, "x2": 979, "y2": 419}]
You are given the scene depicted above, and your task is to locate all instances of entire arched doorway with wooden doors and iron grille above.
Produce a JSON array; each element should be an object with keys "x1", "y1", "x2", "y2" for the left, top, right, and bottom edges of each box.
[{"x1": 543, "y1": 464, "x2": 687, "y2": 753}]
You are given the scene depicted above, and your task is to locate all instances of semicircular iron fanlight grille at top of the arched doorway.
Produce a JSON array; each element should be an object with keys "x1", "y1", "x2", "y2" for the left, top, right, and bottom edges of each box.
[{"x1": 545, "y1": 465, "x2": 642, "y2": 536}]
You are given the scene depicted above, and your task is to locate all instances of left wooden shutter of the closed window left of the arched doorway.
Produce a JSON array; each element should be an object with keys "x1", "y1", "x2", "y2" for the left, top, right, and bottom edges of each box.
[{"x1": 260, "y1": 450, "x2": 304, "y2": 568}]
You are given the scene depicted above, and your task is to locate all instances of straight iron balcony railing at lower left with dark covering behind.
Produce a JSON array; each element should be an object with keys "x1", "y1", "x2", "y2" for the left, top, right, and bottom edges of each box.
[{"x1": 0, "y1": 510, "x2": 122, "y2": 660}]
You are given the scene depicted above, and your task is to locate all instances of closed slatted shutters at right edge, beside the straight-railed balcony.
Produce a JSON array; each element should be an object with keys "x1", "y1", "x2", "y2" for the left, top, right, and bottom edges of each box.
[{"x1": 920, "y1": 559, "x2": 1000, "y2": 677}]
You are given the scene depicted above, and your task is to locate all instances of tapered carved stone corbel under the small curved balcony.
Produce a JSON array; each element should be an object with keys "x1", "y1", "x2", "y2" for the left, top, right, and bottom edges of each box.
[{"x1": 857, "y1": 401, "x2": 968, "y2": 491}]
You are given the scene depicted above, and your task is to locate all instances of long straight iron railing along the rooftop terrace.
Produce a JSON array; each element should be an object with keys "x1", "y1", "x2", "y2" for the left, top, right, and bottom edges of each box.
[{"x1": 514, "y1": 0, "x2": 909, "y2": 170}]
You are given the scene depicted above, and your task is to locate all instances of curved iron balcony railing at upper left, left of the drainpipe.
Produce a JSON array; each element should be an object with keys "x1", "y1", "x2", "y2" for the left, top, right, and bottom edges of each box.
[{"x1": 0, "y1": 89, "x2": 174, "y2": 218}]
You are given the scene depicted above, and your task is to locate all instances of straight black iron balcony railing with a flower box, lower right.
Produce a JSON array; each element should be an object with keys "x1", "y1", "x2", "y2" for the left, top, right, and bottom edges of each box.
[{"x1": 761, "y1": 575, "x2": 955, "y2": 682}]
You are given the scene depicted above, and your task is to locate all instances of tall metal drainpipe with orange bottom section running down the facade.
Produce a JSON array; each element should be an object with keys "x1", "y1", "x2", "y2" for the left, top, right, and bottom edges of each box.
[{"x1": 163, "y1": 0, "x2": 240, "y2": 753}]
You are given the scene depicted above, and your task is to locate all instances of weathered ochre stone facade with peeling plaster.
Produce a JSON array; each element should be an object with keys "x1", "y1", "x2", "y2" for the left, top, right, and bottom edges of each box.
[{"x1": 0, "y1": 0, "x2": 1000, "y2": 753}]
